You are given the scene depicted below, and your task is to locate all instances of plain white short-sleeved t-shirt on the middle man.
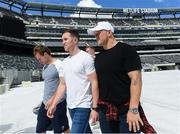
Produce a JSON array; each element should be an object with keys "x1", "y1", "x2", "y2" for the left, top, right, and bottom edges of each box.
[{"x1": 61, "y1": 50, "x2": 95, "y2": 109}]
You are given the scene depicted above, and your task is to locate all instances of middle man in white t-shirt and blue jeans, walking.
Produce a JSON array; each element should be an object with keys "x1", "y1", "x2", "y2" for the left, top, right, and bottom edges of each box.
[{"x1": 47, "y1": 30, "x2": 99, "y2": 133}]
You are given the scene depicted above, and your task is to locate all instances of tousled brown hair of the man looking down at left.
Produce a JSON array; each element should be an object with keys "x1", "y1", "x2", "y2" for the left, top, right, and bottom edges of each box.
[{"x1": 33, "y1": 44, "x2": 51, "y2": 56}]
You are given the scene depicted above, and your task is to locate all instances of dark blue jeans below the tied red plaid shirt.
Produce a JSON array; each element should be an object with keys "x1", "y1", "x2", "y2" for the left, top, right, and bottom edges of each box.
[{"x1": 99, "y1": 108, "x2": 141, "y2": 133}]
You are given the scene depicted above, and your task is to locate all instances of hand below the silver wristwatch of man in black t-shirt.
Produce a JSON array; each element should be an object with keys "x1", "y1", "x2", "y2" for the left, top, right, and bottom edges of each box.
[{"x1": 127, "y1": 111, "x2": 144, "y2": 132}]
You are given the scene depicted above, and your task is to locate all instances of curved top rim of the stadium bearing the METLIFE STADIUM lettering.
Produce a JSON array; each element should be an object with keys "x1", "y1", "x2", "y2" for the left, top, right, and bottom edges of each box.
[{"x1": 0, "y1": 0, "x2": 180, "y2": 17}]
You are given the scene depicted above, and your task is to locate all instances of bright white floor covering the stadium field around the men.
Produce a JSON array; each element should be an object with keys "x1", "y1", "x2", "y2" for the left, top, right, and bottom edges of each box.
[{"x1": 0, "y1": 70, "x2": 180, "y2": 134}]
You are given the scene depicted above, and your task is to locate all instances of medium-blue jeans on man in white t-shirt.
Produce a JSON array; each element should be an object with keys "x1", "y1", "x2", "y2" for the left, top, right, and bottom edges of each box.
[{"x1": 69, "y1": 108, "x2": 91, "y2": 133}]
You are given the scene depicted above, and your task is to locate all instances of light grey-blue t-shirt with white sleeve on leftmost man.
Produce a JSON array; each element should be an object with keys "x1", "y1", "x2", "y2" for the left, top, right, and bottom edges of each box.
[{"x1": 42, "y1": 60, "x2": 65, "y2": 104}]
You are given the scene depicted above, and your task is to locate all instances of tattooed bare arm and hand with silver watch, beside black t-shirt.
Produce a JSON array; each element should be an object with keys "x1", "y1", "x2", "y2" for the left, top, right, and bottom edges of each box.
[{"x1": 127, "y1": 70, "x2": 143, "y2": 132}]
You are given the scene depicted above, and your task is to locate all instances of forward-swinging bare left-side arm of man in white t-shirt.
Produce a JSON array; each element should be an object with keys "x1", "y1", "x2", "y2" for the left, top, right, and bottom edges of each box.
[{"x1": 47, "y1": 77, "x2": 66, "y2": 118}]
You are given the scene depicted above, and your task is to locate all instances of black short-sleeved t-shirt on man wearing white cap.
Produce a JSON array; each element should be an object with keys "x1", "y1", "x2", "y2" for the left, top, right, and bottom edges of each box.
[{"x1": 95, "y1": 42, "x2": 142, "y2": 105}]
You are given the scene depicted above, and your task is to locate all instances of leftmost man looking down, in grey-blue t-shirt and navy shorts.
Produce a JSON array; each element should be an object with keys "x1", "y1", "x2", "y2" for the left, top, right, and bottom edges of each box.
[{"x1": 34, "y1": 45, "x2": 69, "y2": 133}]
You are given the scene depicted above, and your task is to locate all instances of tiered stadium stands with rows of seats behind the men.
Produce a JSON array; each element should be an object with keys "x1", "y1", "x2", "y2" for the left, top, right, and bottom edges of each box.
[{"x1": 0, "y1": 0, "x2": 180, "y2": 87}]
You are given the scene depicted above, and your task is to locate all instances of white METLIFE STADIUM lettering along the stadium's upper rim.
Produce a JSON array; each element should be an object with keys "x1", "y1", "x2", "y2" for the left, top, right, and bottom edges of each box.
[{"x1": 123, "y1": 8, "x2": 158, "y2": 13}]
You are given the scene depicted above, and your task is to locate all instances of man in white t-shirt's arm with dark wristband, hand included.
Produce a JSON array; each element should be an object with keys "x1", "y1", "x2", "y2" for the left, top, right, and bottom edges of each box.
[{"x1": 88, "y1": 72, "x2": 99, "y2": 122}]
